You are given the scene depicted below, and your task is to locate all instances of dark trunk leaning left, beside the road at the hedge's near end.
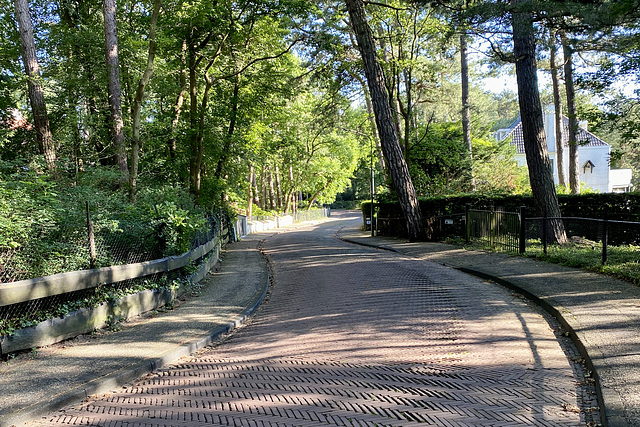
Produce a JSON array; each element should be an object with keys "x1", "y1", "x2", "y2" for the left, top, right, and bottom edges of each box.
[{"x1": 345, "y1": 0, "x2": 423, "y2": 241}]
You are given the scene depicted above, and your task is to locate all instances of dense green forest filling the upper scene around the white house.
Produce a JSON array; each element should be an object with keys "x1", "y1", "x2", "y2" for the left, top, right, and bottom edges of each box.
[{"x1": 0, "y1": 0, "x2": 640, "y2": 247}]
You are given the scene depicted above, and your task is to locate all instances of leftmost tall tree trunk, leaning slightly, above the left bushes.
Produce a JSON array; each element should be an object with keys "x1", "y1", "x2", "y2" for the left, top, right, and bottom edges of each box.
[{"x1": 14, "y1": 0, "x2": 56, "y2": 174}]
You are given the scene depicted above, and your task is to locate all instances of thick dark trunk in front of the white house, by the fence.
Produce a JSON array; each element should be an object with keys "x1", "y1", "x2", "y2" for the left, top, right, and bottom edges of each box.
[{"x1": 511, "y1": 0, "x2": 567, "y2": 244}]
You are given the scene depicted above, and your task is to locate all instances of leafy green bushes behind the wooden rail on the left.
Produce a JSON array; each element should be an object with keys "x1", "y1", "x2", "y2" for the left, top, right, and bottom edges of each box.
[{"x1": 0, "y1": 161, "x2": 215, "y2": 281}]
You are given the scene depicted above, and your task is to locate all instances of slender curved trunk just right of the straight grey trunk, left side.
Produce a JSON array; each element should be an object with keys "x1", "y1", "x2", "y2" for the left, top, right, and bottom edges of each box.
[{"x1": 129, "y1": 0, "x2": 162, "y2": 200}]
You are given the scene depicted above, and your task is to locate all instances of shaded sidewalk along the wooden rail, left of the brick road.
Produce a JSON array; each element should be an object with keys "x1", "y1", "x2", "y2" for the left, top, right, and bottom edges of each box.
[{"x1": 0, "y1": 236, "x2": 268, "y2": 427}]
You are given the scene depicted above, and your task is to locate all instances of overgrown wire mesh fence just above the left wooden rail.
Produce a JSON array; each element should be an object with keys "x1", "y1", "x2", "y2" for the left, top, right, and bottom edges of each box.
[{"x1": 0, "y1": 203, "x2": 229, "y2": 286}]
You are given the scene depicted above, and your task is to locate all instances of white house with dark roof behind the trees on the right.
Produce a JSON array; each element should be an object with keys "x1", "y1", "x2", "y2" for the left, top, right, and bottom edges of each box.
[{"x1": 495, "y1": 106, "x2": 633, "y2": 193}]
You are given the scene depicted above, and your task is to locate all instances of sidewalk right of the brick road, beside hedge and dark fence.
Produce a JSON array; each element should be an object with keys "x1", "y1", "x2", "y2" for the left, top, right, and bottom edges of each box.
[{"x1": 339, "y1": 211, "x2": 640, "y2": 427}]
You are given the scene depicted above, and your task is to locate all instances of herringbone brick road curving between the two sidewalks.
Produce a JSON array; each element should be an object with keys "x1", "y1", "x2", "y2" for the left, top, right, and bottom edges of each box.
[{"x1": 30, "y1": 216, "x2": 584, "y2": 426}]
